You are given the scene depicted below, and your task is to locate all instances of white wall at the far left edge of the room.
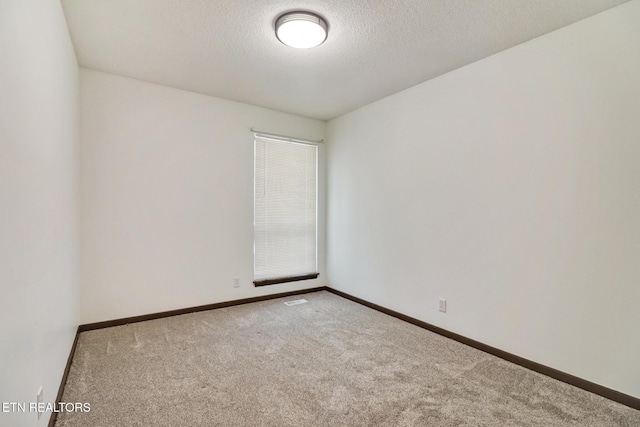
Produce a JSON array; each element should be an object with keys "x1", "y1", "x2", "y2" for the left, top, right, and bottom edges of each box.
[{"x1": 0, "y1": 0, "x2": 79, "y2": 426}]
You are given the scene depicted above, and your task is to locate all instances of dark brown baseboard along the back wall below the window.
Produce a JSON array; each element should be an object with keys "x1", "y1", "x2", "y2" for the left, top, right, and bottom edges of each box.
[{"x1": 78, "y1": 286, "x2": 328, "y2": 332}]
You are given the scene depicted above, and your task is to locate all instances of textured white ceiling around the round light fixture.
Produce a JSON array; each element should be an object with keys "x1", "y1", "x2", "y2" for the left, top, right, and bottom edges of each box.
[{"x1": 62, "y1": 0, "x2": 625, "y2": 120}]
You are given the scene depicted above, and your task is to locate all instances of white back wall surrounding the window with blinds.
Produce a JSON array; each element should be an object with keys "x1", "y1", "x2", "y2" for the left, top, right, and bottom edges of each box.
[{"x1": 80, "y1": 69, "x2": 326, "y2": 323}]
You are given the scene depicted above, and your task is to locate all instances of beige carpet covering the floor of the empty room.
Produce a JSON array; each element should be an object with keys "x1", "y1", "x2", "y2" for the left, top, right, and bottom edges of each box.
[{"x1": 56, "y1": 291, "x2": 640, "y2": 427}]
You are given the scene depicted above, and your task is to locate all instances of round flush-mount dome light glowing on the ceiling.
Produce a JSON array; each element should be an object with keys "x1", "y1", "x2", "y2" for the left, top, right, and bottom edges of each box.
[{"x1": 276, "y1": 12, "x2": 327, "y2": 49}]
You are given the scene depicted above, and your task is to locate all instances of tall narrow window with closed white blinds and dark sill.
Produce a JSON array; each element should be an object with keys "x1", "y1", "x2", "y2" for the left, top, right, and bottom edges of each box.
[{"x1": 253, "y1": 134, "x2": 318, "y2": 286}]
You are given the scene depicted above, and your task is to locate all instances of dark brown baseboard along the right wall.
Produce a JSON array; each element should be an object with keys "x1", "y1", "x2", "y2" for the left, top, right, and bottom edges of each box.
[{"x1": 326, "y1": 287, "x2": 640, "y2": 410}]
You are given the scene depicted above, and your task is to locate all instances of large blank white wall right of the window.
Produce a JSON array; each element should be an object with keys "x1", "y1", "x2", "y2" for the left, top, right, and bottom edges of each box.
[{"x1": 327, "y1": 0, "x2": 640, "y2": 397}]
